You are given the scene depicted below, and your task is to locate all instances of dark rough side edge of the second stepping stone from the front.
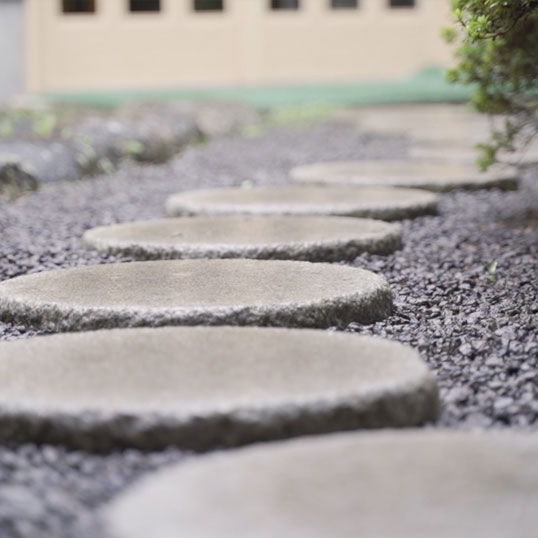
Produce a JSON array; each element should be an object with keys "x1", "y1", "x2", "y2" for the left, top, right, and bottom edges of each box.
[{"x1": 0, "y1": 368, "x2": 440, "y2": 453}]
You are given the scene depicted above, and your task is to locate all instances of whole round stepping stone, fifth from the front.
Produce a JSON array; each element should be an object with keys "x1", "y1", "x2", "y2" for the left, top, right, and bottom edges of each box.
[{"x1": 166, "y1": 186, "x2": 437, "y2": 220}]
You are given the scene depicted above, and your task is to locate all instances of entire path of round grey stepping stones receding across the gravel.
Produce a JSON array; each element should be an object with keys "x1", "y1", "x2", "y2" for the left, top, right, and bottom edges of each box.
[{"x1": 4, "y1": 102, "x2": 538, "y2": 538}]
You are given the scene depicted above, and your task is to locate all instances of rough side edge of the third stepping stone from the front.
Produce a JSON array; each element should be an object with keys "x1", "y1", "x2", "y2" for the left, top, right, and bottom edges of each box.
[{"x1": 0, "y1": 273, "x2": 392, "y2": 332}]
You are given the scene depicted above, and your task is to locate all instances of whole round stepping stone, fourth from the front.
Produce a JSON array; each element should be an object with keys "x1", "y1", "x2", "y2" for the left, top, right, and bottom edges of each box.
[{"x1": 84, "y1": 216, "x2": 401, "y2": 261}]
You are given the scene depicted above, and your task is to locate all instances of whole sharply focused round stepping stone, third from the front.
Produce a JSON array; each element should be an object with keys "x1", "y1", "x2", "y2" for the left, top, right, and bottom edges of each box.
[{"x1": 0, "y1": 260, "x2": 392, "y2": 331}]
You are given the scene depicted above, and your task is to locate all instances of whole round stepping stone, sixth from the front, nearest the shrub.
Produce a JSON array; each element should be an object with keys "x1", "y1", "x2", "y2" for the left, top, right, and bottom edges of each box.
[{"x1": 291, "y1": 160, "x2": 518, "y2": 191}]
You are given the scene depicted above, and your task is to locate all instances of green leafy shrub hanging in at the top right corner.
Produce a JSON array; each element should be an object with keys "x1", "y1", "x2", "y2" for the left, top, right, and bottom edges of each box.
[{"x1": 444, "y1": 0, "x2": 538, "y2": 168}]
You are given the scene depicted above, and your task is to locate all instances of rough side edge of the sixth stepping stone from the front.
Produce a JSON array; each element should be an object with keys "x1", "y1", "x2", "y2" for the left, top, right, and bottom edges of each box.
[{"x1": 290, "y1": 161, "x2": 520, "y2": 192}]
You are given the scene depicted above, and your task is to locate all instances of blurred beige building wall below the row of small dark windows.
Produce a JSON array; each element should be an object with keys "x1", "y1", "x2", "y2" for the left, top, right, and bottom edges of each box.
[{"x1": 26, "y1": 0, "x2": 450, "y2": 92}]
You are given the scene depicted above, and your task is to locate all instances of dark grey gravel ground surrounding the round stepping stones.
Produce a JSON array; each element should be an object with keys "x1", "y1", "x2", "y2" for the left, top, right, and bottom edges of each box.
[{"x1": 0, "y1": 118, "x2": 538, "y2": 538}]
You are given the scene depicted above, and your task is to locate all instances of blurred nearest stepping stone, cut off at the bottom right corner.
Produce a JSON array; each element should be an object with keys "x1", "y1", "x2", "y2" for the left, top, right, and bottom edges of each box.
[{"x1": 103, "y1": 430, "x2": 538, "y2": 538}]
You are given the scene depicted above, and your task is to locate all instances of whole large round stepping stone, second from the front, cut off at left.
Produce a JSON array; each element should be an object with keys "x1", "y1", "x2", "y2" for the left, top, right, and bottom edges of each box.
[{"x1": 0, "y1": 327, "x2": 438, "y2": 448}]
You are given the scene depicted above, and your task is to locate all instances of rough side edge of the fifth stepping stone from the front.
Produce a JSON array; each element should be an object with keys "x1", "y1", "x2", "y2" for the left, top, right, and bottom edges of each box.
[{"x1": 165, "y1": 191, "x2": 439, "y2": 221}]
